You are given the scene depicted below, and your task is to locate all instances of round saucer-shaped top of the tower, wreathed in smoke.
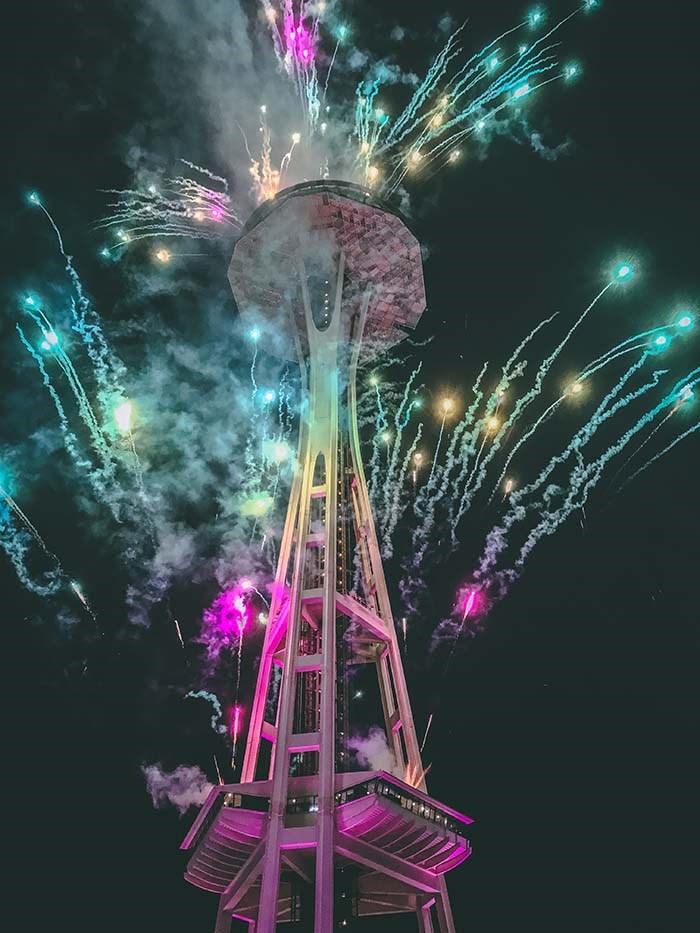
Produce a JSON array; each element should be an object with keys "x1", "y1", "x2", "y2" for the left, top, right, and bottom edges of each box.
[{"x1": 229, "y1": 181, "x2": 425, "y2": 359}]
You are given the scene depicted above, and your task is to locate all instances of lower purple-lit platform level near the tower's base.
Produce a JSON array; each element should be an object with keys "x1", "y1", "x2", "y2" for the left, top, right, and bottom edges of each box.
[{"x1": 181, "y1": 771, "x2": 473, "y2": 922}]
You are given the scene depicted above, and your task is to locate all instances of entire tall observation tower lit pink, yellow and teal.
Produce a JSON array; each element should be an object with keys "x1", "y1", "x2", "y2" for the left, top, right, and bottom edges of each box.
[{"x1": 182, "y1": 182, "x2": 471, "y2": 933}]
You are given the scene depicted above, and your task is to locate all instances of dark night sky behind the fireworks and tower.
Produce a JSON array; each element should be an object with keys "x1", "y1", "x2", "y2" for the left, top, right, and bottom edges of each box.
[{"x1": 0, "y1": 0, "x2": 700, "y2": 933}]
